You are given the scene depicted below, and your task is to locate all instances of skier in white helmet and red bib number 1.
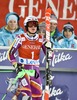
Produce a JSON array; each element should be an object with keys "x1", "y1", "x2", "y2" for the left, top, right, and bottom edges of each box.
[{"x1": 8, "y1": 16, "x2": 43, "y2": 100}]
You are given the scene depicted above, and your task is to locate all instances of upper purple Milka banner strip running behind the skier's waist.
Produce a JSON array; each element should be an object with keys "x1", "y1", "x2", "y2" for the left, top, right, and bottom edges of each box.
[{"x1": 0, "y1": 46, "x2": 77, "y2": 70}]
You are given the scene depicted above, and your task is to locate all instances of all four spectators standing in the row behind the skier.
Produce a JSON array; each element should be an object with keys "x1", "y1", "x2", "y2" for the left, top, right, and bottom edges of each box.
[{"x1": 0, "y1": 12, "x2": 77, "y2": 48}]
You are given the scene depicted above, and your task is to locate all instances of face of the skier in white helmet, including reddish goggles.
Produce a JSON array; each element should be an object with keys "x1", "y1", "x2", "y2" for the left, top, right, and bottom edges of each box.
[{"x1": 28, "y1": 21, "x2": 38, "y2": 34}]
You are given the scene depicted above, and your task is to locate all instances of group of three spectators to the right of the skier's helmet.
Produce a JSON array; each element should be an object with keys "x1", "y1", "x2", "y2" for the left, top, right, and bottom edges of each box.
[{"x1": 39, "y1": 14, "x2": 77, "y2": 49}]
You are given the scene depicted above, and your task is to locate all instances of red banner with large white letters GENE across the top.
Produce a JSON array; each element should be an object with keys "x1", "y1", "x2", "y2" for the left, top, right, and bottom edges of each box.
[{"x1": 0, "y1": 0, "x2": 77, "y2": 35}]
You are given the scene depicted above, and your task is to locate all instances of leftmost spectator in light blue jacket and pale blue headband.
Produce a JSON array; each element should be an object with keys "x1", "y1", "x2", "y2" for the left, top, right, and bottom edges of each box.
[{"x1": 0, "y1": 12, "x2": 24, "y2": 46}]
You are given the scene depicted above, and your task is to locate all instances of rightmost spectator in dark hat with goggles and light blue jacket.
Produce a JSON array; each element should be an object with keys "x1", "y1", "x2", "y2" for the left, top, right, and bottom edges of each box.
[{"x1": 57, "y1": 22, "x2": 77, "y2": 48}]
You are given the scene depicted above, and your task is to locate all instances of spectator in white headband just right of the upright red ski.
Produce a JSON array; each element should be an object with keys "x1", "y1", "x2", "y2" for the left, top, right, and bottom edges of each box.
[{"x1": 50, "y1": 14, "x2": 61, "y2": 45}]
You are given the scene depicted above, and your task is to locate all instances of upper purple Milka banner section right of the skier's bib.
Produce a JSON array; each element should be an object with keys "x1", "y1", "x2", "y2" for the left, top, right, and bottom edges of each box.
[{"x1": 40, "y1": 49, "x2": 77, "y2": 69}]
